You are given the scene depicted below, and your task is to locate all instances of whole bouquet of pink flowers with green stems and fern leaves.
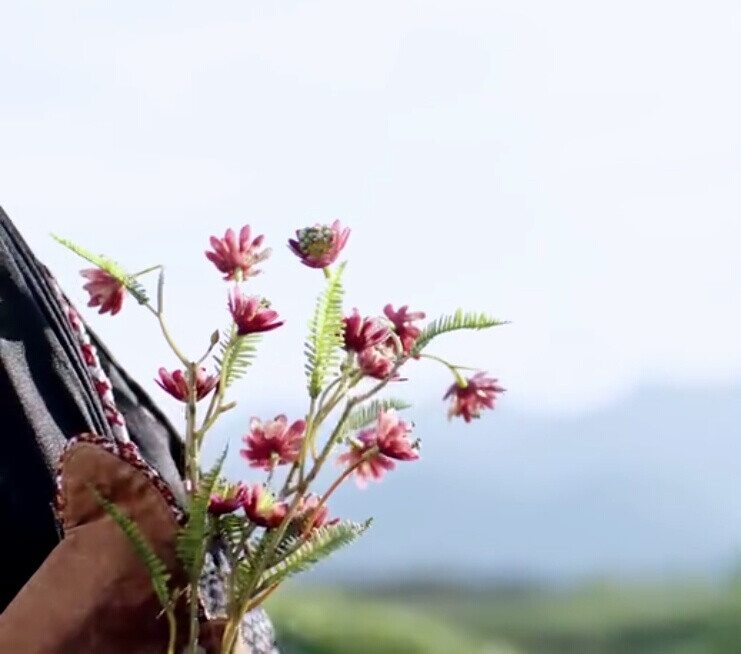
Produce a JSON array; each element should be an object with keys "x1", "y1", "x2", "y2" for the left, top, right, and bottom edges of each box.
[{"x1": 58, "y1": 222, "x2": 504, "y2": 654}]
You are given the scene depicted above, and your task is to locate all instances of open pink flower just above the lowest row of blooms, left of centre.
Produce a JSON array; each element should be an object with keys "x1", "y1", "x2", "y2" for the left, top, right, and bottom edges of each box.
[{"x1": 240, "y1": 415, "x2": 306, "y2": 470}]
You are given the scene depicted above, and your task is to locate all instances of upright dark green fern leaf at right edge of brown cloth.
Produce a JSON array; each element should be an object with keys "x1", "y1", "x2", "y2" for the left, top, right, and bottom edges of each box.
[{"x1": 176, "y1": 450, "x2": 226, "y2": 577}]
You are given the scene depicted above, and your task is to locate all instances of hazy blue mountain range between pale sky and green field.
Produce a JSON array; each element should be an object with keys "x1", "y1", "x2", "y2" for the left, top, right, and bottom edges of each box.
[{"x1": 205, "y1": 386, "x2": 741, "y2": 580}]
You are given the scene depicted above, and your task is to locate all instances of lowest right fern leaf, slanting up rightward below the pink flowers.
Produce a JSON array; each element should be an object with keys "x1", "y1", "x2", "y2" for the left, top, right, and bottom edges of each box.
[{"x1": 260, "y1": 520, "x2": 371, "y2": 589}]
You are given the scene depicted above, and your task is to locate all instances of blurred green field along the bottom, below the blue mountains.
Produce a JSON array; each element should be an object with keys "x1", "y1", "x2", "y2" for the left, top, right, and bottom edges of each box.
[{"x1": 268, "y1": 583, "x2": 741, "y2": 654}]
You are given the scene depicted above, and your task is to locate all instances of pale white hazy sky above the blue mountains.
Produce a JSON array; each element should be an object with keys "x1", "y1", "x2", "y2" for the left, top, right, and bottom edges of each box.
[{"x1": 0, "y1": 0, "x2": 741, "y2": 420}]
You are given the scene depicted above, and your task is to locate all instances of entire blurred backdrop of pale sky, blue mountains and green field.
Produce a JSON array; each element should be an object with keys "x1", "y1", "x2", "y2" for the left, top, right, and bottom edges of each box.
[{"x1": 0, "y1": 0, "x2": 741, "y2": 654}]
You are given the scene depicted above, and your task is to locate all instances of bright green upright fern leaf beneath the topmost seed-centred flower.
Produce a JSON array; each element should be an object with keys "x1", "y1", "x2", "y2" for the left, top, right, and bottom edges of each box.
[{"x1": 305, "y1": 263, "x2": 345, "y2": 398}]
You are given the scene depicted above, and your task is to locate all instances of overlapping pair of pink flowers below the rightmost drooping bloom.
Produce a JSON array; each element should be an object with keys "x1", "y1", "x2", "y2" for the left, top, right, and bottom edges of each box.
[{"x1": 338, "y1": 410, "x2": 419, "y2": 488}]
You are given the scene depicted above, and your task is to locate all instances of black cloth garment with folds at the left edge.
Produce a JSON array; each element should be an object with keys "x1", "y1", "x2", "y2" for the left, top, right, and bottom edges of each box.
[{"x1": 0, "y1": 208, "x2": 182, "y2": 611}]
